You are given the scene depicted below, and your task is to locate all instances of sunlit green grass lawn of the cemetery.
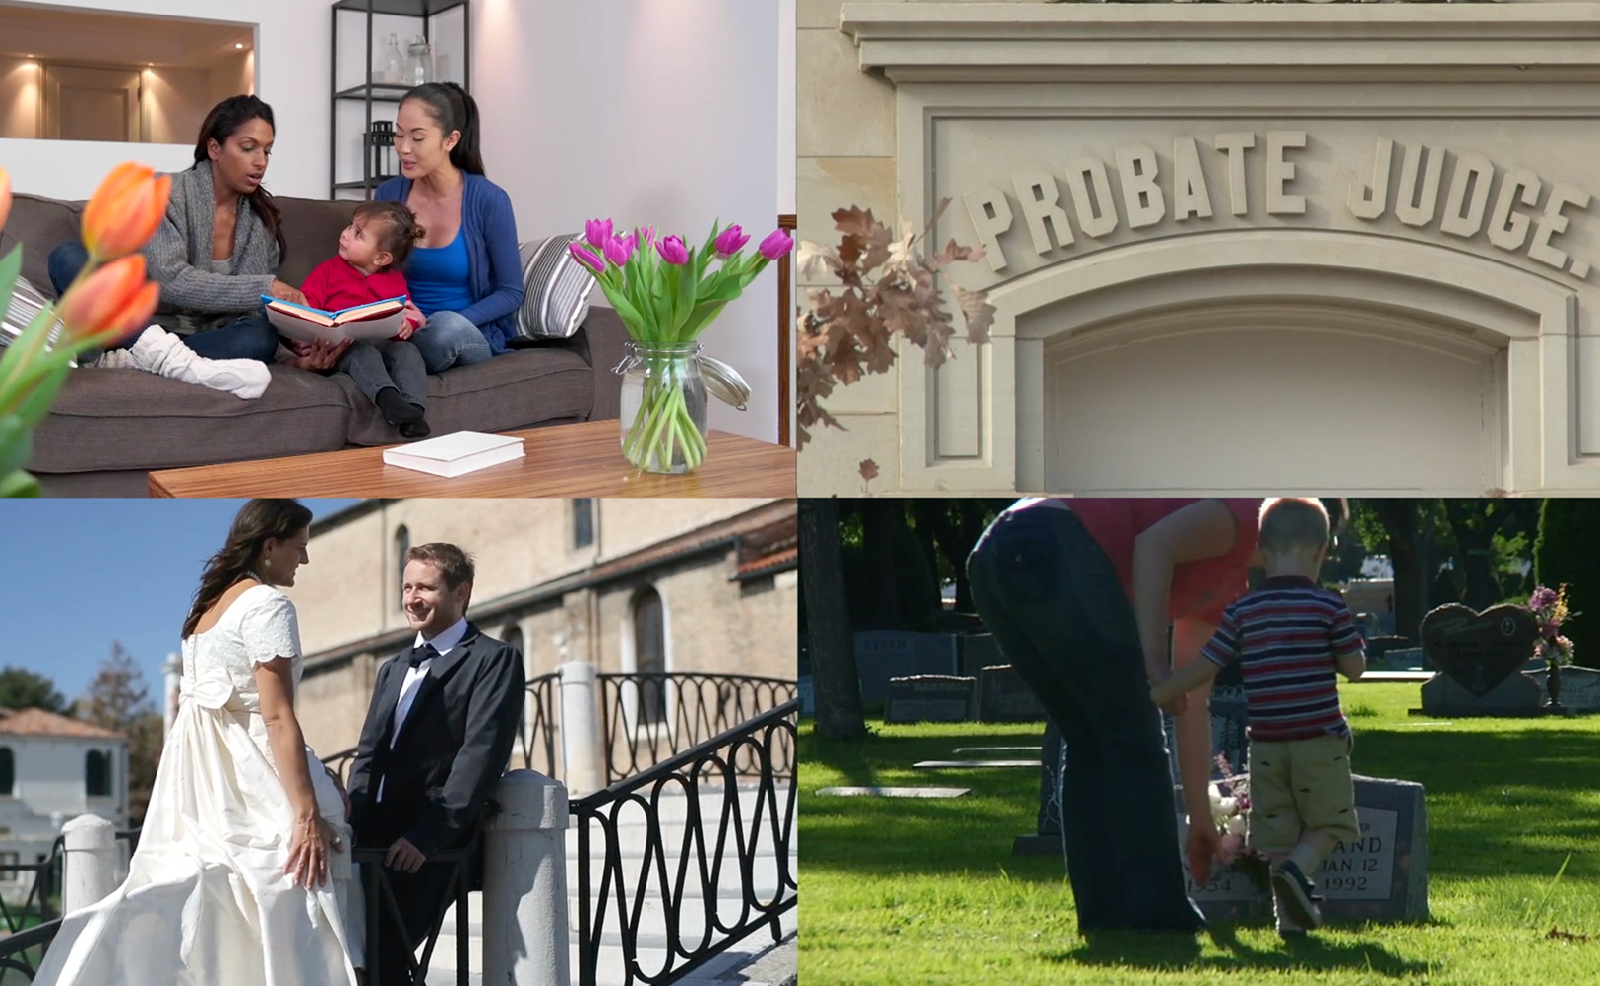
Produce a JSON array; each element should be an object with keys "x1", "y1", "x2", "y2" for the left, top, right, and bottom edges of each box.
[{"x1": 800, "y1": 683, "x2": 1600, "y2": 986}]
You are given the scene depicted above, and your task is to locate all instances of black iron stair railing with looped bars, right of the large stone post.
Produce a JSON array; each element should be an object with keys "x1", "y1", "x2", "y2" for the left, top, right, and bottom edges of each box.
[{"x1": 571, "y1": 699, "x2": 800, "y2": 986}]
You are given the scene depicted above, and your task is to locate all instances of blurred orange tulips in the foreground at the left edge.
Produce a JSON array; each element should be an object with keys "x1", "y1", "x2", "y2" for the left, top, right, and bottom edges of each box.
[{"x1": 0, "y1": 162, "x2": 171, "y2": 496}]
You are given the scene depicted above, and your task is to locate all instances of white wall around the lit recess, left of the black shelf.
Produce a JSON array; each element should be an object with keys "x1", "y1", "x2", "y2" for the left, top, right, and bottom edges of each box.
[{"x1": 0, "y1": 0, "x2": 331, "y2": 198}]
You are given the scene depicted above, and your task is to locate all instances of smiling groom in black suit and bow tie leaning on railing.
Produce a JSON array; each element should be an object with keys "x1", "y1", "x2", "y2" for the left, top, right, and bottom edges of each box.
[{"x1": 349, "y1": 543, "x2": 525, "y2": 986}]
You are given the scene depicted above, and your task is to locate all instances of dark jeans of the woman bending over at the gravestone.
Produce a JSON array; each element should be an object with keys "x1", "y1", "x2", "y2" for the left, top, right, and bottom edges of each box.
[{"x1": 966, "y1": 504, "x2": 1205, "y2": 932}]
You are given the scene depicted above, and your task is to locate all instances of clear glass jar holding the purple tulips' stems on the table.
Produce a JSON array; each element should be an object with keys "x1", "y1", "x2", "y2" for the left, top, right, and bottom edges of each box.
[{"x1": 618, "y1": 341, "x2": 706, "y2": 472}]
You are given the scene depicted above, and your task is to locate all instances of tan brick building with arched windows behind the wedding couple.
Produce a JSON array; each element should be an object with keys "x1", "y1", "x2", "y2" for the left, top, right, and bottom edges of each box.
[{"x1": 288, "y1": 499, "x2": 798, "y2": 752}]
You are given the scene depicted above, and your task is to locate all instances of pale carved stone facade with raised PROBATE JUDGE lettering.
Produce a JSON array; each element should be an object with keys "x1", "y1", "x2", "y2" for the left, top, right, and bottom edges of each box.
[{"x1": 797, "y1": 0, "x2": 1600, "y2": 496}]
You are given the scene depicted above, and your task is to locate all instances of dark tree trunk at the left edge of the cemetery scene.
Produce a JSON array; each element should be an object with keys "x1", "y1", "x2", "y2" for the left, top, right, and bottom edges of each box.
[{"x1": 800, "y1": 498, "x2": 867, "y2": 740}]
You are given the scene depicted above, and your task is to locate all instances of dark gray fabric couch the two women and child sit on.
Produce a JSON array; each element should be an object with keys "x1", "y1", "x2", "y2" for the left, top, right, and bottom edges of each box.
[{"x1": 0, "y1": 195, "x2": 627, "y2": 496}]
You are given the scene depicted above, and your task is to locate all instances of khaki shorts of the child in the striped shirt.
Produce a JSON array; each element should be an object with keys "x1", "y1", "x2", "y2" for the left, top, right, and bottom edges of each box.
[{"x1": 1250, "y1": 735, "x2": 1362, "y2": 853}]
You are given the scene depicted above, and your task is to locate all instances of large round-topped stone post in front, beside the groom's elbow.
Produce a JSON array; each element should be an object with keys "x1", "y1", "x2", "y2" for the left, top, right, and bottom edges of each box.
[{"x1": 483, "y1": 770, "x2": 571, "y2": 986}]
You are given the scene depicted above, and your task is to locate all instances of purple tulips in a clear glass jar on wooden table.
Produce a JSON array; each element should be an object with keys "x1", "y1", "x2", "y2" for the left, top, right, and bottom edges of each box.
[{"x1": 568, "y1": 219, "x2": 794, "y2": 472}]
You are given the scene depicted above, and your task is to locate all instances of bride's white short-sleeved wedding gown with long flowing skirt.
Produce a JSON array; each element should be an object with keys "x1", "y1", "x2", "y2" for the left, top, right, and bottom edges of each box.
[{"x1": 34, "y1": 586, "x2": 362, "y2": 986}]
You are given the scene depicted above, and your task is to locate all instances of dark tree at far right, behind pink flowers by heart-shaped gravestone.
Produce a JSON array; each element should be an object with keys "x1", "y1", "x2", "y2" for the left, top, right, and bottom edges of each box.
[{"x1": 1533, "y1": 498, "x2": 1600, "y2": 667}]
